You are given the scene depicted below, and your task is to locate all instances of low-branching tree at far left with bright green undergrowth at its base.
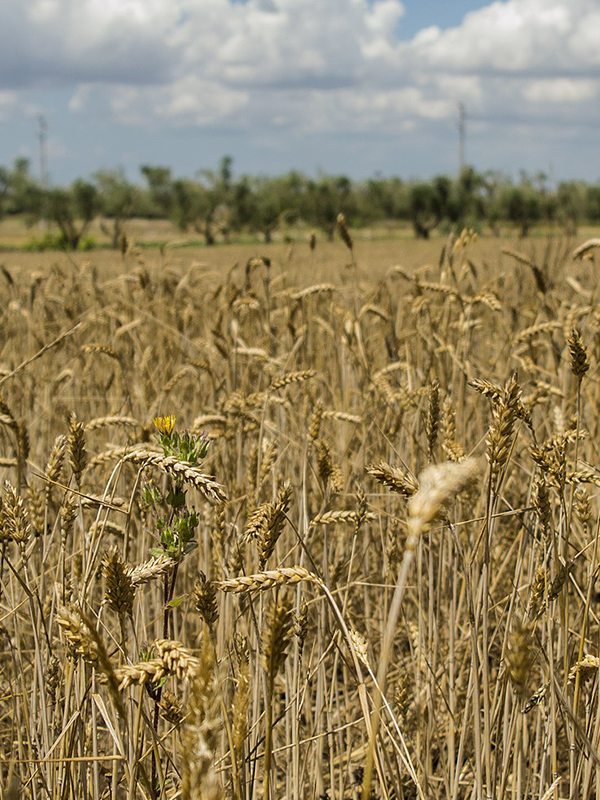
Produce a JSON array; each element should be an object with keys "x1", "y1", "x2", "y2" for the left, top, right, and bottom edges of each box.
[{"x1": 44, "y1": 180, "x2": 100, "y2": 250}]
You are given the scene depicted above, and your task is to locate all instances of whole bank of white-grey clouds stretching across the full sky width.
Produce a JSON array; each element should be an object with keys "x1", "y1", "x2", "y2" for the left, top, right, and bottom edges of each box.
[{"x1": 0, "y1": 0, "x2": 600, "y2": 143}]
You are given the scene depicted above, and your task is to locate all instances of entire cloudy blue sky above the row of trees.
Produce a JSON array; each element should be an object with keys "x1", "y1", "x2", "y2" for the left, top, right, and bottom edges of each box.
[{"x1": 0, "y1": 0, "x2": 600, "y2": 184}]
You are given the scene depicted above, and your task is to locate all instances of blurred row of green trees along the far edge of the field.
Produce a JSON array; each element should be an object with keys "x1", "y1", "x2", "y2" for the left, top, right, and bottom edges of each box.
[{"x1": 0, "y1": 156, "x2": 600, "y2": 249}]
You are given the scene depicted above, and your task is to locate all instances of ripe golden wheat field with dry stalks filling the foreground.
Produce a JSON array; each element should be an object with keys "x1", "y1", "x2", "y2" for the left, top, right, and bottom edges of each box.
[{"x1": 0, "y1": 228, "x2": 600, "y2": 800}]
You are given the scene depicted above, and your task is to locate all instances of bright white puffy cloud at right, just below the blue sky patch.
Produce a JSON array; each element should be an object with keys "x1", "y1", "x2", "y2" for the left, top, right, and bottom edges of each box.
[{"x1": 407, "y1": 0, "x2": 600, "y2": 132}]
